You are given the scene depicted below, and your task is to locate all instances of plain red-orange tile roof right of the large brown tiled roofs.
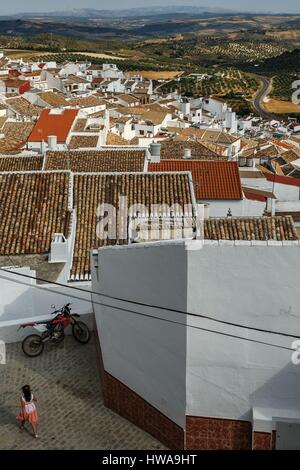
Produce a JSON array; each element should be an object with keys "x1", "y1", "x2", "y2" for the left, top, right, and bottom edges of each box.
[{"x1": 149, "y1": 160, "x2": 243, "y2": 200}]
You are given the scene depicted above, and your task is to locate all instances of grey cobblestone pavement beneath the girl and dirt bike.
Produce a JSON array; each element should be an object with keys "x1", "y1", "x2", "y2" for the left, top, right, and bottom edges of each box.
[{"x1": 0, "y1": 337, "x2": 164, "y2": 450}]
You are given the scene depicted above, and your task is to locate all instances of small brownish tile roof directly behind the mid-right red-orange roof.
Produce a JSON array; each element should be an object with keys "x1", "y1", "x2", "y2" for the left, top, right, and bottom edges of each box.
[{"x1": 161, "y1": 139, "x2": 227, "y2": 160}]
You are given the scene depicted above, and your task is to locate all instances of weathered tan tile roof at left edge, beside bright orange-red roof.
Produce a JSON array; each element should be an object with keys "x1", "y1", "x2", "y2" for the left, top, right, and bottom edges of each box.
[{"x1": 0, "y1": 121, "x2": 34, "y2": 154}]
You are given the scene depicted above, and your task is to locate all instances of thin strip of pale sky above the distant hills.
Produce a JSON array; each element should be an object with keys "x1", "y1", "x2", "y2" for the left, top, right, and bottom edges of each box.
[{"x1": 0, "y1": 0, "x2": 300, "y2": 15}]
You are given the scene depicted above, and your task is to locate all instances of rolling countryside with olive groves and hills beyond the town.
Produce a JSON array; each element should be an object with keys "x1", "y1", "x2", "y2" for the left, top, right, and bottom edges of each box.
[{"x1": 0, "y1": 7, "x2": 300, "y2": 115}]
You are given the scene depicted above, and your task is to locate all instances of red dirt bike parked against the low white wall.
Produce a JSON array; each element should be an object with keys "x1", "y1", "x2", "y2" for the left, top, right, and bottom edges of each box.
[{"x1": 20, "y1": 304, "x2": 91, "y2": 357}]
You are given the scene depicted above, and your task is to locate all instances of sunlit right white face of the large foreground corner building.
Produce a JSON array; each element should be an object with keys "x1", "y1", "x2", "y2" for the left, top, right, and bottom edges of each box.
[{"x1": 187, "y1": 244, "x2": 300, "y2": 426}]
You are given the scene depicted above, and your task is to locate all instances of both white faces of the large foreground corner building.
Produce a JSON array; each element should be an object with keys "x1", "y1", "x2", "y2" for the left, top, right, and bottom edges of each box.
[{"x1": 93, "y1": 241, "x2": 300, "y2": 430}]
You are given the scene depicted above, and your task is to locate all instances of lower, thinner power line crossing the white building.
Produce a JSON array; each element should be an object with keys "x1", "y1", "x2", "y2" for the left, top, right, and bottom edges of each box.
[{"x1": 0, "y1": 275, "x2": 300, "y2": 352}]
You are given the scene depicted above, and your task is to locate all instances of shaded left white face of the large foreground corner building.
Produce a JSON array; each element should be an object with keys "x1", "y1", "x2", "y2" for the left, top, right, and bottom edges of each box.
[{"x1": 92, "y1": 244, "x2": 187, "y2": 427}]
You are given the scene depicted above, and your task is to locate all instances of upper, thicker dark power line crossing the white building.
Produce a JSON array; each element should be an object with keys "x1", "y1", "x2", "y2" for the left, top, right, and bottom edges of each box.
[{"x1": 0, "y1": 268, "x2": 300, "y2": 339}]
